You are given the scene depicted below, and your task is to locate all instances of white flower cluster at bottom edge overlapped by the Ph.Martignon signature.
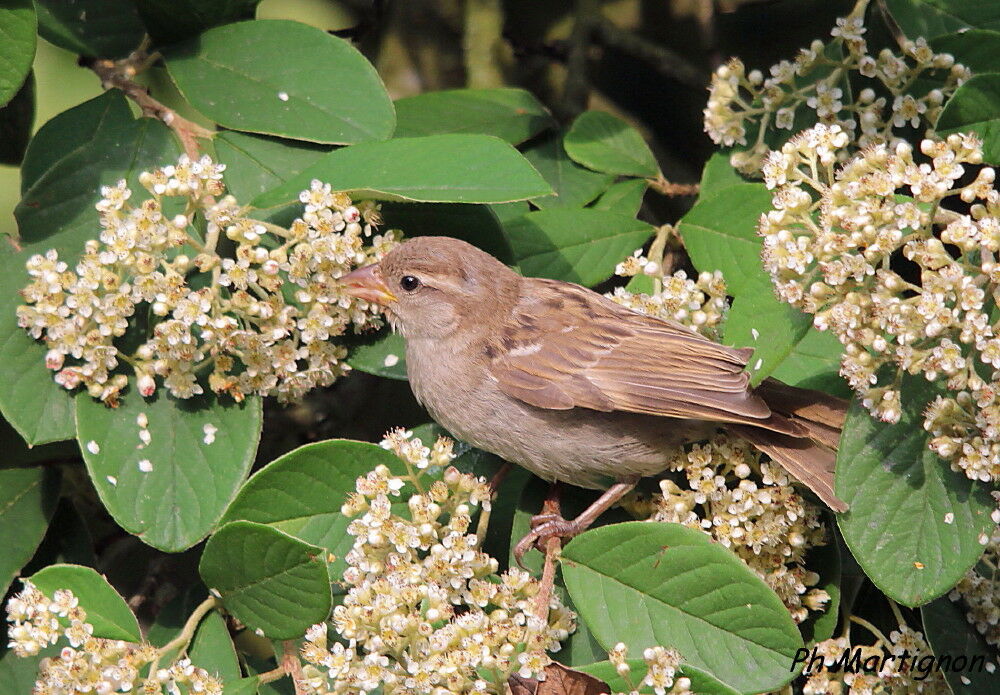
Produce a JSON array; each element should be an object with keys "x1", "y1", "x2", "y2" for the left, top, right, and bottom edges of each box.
[{"x1": 802, "y1": 621, "x2": 951, "y2": 695}]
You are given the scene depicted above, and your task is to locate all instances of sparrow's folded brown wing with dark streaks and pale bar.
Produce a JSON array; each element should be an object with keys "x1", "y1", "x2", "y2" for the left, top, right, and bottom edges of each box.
[{"x1": 485, "y1": 280, "x2": 771, "y2": 423}]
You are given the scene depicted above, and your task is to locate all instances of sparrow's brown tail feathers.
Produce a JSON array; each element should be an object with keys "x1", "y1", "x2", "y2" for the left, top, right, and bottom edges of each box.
[{"x1": 727, "y1": 379, "x2": 847, "y2": 512}]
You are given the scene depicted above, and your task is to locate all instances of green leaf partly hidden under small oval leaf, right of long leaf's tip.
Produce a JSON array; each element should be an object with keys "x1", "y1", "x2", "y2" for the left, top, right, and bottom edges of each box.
[{"x1": 524, "y1": 133, "x2": 614, "y2": 208}]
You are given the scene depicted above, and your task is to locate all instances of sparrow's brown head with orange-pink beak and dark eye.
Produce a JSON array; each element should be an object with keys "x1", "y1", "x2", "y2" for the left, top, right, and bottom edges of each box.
[{"x1": 341, "y1": 237, "x2": 520, "y2": 340}]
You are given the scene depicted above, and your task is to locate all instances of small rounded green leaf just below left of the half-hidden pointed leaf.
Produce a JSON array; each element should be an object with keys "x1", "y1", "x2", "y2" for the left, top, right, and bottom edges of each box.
[{"x1": 199, "y1": 521, "x2": 331, "y2": 639}]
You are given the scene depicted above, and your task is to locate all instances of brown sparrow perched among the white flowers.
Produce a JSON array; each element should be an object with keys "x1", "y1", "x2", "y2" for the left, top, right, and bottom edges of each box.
[{"x1": 341, "y1": 236, "x2": 847, "y2": 558}]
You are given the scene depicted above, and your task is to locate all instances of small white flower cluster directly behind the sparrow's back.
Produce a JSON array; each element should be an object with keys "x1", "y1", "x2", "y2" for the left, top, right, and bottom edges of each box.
[{"x1": 606, "y1": 249, "x2": 729, "y2": 339}]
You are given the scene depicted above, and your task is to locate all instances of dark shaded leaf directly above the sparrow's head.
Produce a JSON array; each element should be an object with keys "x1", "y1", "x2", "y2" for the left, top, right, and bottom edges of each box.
[{"x1": 382, "y1": 203, "x2": 512, "y2": 264}]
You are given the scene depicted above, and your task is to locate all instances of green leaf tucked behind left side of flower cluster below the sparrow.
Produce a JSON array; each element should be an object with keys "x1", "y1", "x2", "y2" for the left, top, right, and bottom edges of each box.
[{"x1": 221, "y1": 439, "x2": 405, "y2": 581}]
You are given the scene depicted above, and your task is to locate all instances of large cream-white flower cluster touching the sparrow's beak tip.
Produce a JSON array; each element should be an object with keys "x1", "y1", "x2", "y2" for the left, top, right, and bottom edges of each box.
[{"x1": 17, "y1": 155, "x2": 398, "y2": 404}]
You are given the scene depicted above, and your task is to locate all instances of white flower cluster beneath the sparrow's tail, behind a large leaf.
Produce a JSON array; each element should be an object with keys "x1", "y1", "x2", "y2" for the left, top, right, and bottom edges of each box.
[{"x1": 652, "y1": 434, "x2": 830, "y2": 622}]
